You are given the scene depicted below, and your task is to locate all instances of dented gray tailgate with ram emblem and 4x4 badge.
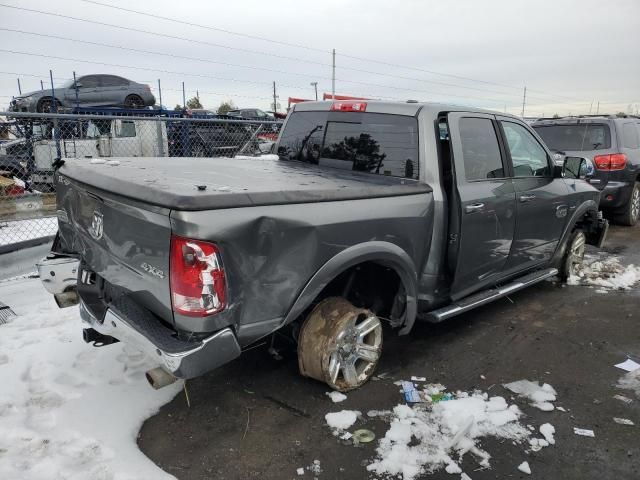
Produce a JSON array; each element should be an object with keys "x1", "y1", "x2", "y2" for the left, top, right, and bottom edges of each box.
[{"x1": 57, "y1": 176, "x2": 173, "y2": 322}]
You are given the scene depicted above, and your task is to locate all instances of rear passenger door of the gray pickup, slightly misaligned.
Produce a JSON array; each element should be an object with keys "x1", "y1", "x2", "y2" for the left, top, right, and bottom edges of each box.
[{"x1": 448, "y1": 113, "x2": 516, "y2": 299}]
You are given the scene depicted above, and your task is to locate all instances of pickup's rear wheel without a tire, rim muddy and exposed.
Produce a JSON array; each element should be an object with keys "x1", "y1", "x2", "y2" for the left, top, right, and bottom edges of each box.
[{"x1": 298, "y1": 297, "x2": 382, "y2": 392}]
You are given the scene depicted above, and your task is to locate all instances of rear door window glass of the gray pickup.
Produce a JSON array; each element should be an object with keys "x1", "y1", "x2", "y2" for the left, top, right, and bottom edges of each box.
[{"x1": 460, "y1": 117, "x2": 505, "y2": 180}]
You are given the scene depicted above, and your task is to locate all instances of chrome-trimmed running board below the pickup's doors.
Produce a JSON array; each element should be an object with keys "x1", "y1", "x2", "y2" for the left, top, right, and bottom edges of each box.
[{"x1": 424, "y1": 268, "x2": 558, "y2": 323}]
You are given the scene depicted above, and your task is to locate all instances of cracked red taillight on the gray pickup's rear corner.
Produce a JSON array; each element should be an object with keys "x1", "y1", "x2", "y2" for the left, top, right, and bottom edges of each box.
[{"x1": 169, "y1": 236, "x2": 227, "y2": 317}]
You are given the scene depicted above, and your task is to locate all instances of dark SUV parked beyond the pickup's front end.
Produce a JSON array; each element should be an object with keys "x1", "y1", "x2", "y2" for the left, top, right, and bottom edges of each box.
[{"x1": 533, "y1": 116, "x2": 640, "y2": 225}]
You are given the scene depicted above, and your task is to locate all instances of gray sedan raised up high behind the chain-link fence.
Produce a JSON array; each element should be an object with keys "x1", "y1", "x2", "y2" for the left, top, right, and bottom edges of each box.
[{"x1": 9, "y1": 74, "x2": 156, "y2": 113}]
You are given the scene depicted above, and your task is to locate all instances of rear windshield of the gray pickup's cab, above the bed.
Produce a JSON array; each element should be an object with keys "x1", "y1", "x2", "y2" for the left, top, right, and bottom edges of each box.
[{"x1": 278, "y1": 112, "x2": 419, "y2": 179}]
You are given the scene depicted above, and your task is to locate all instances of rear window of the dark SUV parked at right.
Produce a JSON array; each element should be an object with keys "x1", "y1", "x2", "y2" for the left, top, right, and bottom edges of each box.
[{"x1": 533, "y1": 123, "x2": 611, "y2": 152}]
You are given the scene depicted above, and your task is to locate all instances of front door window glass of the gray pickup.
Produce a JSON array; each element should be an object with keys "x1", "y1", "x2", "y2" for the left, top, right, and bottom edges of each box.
[{"x1": 500, "y1": 122, "x2": 551, "y2": 177}]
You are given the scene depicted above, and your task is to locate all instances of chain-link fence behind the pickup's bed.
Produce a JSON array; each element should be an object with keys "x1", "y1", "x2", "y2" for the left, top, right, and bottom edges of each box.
[{"x1": 0, "y1": 110, "x2": 282, "y2": 253}]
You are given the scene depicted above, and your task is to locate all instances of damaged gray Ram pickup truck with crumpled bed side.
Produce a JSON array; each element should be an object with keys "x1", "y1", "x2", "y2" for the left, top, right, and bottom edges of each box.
[{"x1": 39, "y1": 101, "x2": 608, "y2": 391}]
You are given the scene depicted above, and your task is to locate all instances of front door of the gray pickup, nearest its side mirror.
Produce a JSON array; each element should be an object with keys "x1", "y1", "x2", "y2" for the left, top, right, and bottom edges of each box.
[{"x1": 498, "y1": 117, "x2": 575, "y2": 271}]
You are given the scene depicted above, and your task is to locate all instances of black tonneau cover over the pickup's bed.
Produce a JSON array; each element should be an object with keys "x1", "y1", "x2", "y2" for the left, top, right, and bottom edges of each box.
[{"x1": 60, "y1": 157, "x2": 431, "y2": 210}]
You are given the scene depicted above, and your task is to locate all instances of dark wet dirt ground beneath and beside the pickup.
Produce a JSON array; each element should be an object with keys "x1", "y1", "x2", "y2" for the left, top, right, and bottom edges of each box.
[{"x1": 139, "y1": 227, "x2": 640, "y2": 480}]
